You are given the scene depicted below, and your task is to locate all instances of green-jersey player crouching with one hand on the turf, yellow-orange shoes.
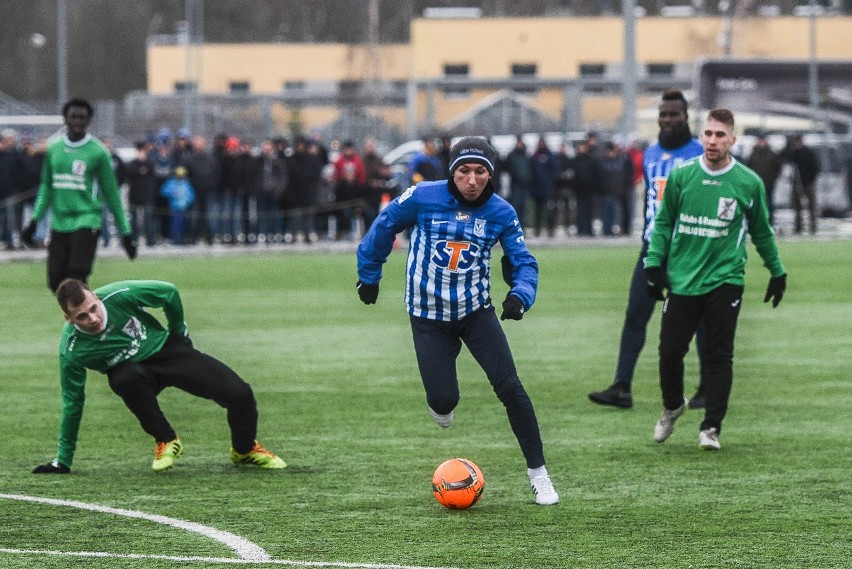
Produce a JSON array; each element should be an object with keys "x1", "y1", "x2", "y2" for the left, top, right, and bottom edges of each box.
[{"x1": 33, "y1": 279, "x2": 287, "y2": 474}]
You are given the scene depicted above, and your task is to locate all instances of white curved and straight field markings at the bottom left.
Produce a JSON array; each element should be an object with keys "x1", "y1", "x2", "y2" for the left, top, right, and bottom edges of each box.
[{"x1": 0, "y1": 494, "x2": 462, "y2": 569}]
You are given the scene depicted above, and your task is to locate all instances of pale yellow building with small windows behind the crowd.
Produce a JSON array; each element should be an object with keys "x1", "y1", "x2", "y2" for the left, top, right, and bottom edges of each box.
[{"x1": 148, "y1": 16, "x2": 852, "y2": 133}]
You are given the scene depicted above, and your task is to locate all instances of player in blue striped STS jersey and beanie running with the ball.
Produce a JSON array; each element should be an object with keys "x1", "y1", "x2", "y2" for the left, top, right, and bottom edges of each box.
[{"x1": 357, "y1": 137, "x2": 559, "y2": 505}]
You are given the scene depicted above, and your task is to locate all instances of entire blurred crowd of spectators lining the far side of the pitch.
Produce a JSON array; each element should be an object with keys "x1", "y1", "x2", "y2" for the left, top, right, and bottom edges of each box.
[{"x1": 0, "y1": 128, "x2": 815, "y2": 249}]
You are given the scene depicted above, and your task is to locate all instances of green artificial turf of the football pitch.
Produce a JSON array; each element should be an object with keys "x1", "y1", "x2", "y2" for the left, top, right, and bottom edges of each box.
[{"x1": 0, "y1": 237, "x2": 852, "y2": 569}]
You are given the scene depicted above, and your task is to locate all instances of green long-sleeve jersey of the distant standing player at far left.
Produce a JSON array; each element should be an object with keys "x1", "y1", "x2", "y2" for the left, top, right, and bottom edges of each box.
[{"x1": 33, "y1": 134, "x2": 130, "y2": 235}]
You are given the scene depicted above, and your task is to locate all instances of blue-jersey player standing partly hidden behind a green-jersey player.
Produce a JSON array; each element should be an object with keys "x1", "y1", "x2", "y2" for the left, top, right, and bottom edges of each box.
[{"x1": 589, "y1": 89, "x2": 704, "y2": 409}]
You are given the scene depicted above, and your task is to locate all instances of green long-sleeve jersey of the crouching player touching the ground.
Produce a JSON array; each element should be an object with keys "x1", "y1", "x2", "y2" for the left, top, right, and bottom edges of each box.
[{"x1": 56, "y1": 281, "x2": 186, "y2": 466}]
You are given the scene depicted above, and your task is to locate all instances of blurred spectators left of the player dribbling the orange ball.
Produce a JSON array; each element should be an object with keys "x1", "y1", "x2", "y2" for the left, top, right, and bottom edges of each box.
[{"x1": 0, "y1": 129, "x2": 397, "y2": 248}]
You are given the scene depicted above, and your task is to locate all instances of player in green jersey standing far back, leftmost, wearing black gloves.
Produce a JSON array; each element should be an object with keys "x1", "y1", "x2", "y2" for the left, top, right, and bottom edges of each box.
[{"x1": 21, "y1": 99, "x2": 136, "y2": 292}]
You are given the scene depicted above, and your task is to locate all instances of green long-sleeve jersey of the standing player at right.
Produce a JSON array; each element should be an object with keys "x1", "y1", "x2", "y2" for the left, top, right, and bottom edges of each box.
[{"x1": 645, "y1": 156, "x2": 786, "y2": 296}]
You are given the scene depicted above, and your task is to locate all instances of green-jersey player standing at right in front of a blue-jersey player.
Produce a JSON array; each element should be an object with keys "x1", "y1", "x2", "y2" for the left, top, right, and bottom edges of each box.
[{"x1": 645, "y1": 109, "x2": 787, "y2": 450}]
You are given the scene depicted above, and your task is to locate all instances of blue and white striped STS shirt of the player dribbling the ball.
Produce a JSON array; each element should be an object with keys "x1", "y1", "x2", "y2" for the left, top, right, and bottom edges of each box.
[{"x1": 357, "y1": 180, "x2": 538, "y2": 322}]
